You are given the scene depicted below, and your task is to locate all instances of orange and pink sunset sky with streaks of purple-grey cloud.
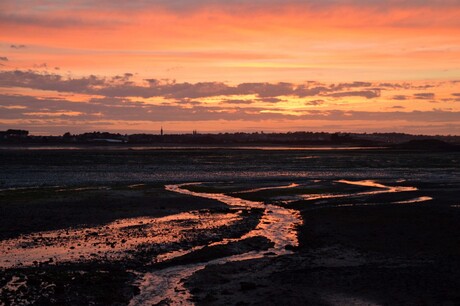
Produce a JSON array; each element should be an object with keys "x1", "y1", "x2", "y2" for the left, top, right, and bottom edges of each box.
[{"x1": 0, "y1": 0, "x2": 460, "y2": 135}]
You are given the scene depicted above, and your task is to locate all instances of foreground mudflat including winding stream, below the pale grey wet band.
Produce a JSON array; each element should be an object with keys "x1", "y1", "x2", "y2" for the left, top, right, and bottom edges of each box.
[{"x1": 0, "y1": 150, "x2": 460, "y2": 305}]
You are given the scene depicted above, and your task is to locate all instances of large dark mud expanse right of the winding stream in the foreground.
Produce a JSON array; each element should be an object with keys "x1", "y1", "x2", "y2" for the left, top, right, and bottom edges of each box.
[{"x1": 186, "y1": 183, "x2": 460, "y2": 305}]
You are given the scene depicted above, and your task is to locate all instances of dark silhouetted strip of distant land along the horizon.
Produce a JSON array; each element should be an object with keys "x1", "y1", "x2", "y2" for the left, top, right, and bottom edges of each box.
[{"x1": 0, "y1": 129, "x2": 460, "y2": 150}]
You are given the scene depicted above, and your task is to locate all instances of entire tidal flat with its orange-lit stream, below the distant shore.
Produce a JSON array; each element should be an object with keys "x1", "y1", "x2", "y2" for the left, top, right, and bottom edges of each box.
[{"x1": 0, "y1": 148, "x2": 460, "y2": 305}]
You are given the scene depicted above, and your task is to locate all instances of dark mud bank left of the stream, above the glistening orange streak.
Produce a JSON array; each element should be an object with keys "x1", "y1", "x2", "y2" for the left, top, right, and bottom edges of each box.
[{"x1": 0, "y1": 183, "x2": 226, "y2": 239}]
